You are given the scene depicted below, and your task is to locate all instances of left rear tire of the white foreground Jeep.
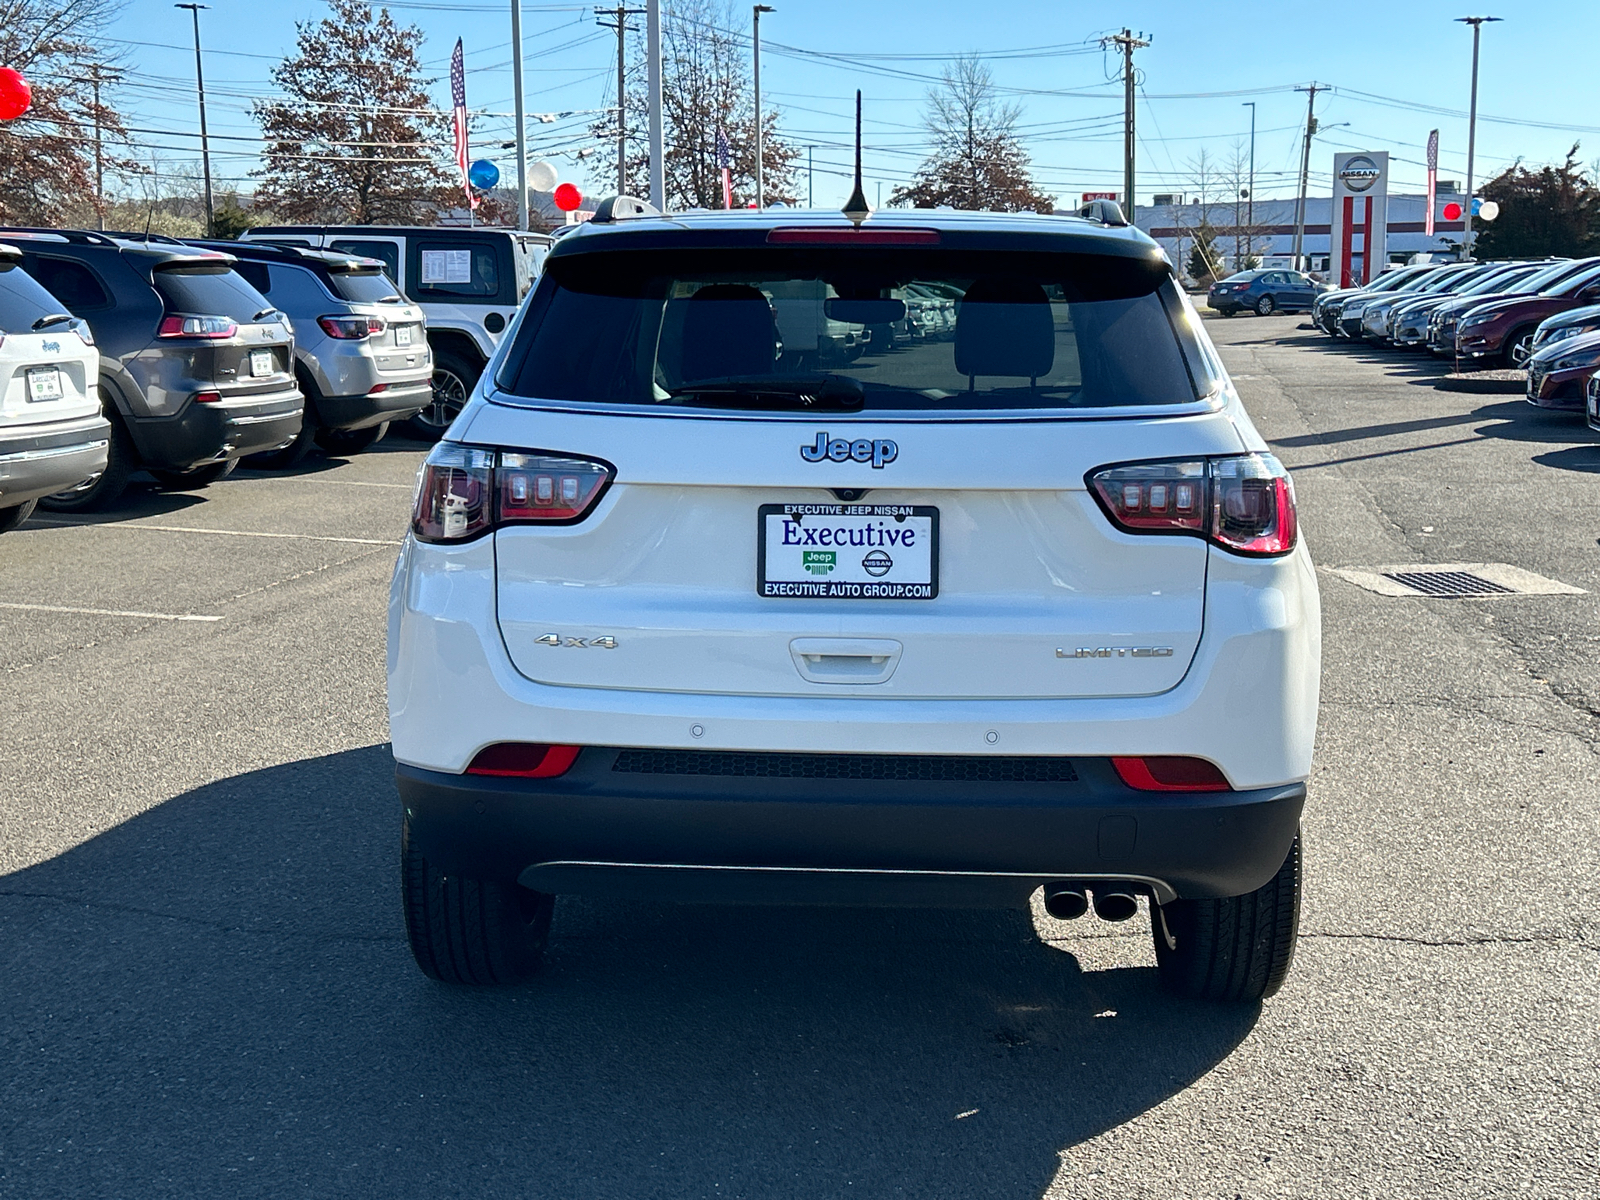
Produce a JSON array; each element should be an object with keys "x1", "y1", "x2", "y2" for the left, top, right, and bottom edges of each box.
[{"x1": 400, "y1": 822, "x2": 555, "y2": 984}]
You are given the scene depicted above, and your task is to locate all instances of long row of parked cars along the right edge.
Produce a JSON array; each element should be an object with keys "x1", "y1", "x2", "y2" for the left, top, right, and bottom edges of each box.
[{"x1": 1312, "y1": 256, "x2": 1600, "y2": 429}]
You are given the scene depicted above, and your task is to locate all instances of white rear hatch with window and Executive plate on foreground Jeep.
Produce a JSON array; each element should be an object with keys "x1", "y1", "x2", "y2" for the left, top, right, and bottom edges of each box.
[{"x1": 480, "y1": 232, "x2": 1242, "y2": 698}]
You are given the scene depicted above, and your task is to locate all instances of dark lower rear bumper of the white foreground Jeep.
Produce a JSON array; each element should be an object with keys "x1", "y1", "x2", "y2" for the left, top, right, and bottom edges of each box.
[{"x1": 395, "y1": 747, "x2": 1306, "y2": 906}]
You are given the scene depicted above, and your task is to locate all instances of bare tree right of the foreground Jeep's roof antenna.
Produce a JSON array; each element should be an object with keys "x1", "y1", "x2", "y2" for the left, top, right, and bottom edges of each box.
[{"x1": 890, "y1": 56, "x2": 1054, "y2": 213}]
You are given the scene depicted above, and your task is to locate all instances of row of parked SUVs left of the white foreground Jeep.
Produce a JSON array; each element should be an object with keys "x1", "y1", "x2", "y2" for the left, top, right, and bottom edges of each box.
[{"x1": 0, "y1": 227, "x2": 549, "y2": 531}]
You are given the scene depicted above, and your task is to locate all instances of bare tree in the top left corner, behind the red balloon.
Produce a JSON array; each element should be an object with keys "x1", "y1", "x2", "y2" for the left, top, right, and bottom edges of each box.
[{"x1": 0, "y1": 0, "x2": 133, "y2": 224}]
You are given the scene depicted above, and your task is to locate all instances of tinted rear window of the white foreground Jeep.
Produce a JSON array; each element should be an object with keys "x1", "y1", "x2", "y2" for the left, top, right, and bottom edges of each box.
[{"x1": 499, "y1": 248, "x2": 1214, "y2": 413}]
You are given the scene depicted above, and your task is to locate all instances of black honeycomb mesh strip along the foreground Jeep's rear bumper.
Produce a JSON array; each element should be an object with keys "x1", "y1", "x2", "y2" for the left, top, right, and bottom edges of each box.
[{"x1": 611, "y1": 750, "x2": 1078, "y2": 784}]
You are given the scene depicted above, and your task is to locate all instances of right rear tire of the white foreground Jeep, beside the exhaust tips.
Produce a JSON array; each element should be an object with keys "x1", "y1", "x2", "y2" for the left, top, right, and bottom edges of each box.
[{"x1": 1150, "y1": 837, "x2": 1301, "y2": 1002}]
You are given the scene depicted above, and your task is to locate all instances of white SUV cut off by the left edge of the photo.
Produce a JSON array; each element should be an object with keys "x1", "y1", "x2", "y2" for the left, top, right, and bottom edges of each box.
[{"x1": 0, "y1": 243, "x2": 110, "y2": 533}]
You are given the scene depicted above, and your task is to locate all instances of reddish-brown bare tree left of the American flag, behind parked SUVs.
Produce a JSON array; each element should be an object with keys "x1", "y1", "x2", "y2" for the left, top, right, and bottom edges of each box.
[{"x1": 254, "y1": 0, "x2": 464, "y2": 224}]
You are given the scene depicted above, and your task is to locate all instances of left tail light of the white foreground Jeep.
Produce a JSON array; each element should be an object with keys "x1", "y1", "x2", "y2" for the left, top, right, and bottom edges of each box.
[{"x1": 411, "y1": 442, "x2": 616, "y2": 542}]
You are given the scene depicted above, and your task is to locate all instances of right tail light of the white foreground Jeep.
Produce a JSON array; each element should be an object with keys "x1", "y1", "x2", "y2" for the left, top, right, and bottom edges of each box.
[{"x1": 1088, "y1": 454, "x2": 1298, "y2": 557}]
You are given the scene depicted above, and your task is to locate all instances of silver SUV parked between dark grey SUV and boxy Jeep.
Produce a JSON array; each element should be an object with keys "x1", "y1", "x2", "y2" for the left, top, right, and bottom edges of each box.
[{"x1": 189, "y1": 240, "x2": 434, "y2": 467}]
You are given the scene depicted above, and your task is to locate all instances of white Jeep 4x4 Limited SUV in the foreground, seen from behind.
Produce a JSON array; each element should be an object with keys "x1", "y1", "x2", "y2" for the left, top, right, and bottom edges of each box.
[{"x1": 389, "y1": 211, "x2": 1320, "y2": 1000}]
